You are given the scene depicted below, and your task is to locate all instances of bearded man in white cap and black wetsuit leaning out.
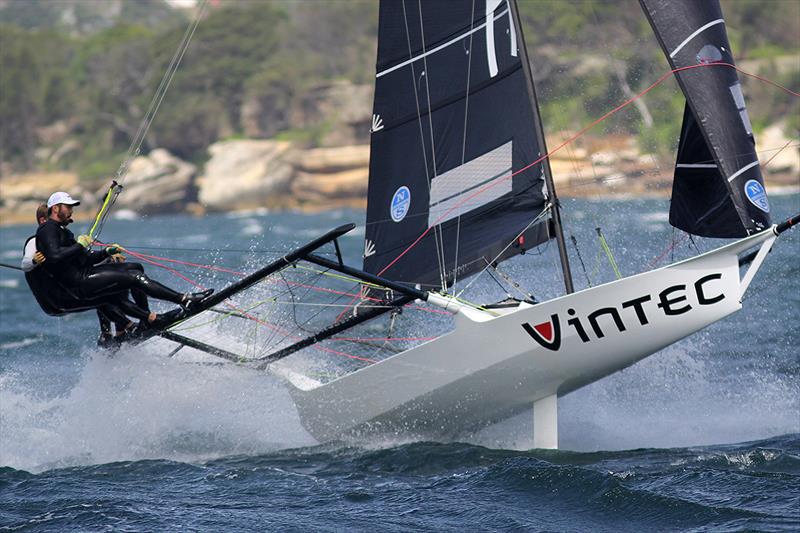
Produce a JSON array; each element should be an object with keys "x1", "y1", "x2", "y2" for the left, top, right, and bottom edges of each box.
[{"x1": 36, "y1": 192, "x2": 213, "y2": 328}]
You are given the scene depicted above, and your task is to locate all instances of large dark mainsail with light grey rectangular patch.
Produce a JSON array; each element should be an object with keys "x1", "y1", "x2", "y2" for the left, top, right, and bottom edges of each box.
[{"x1": 364, "y1": 0, "x2": 552, "y2": 288}]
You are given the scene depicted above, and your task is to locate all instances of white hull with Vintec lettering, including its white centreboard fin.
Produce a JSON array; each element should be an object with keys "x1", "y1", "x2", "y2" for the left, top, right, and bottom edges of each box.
[{"x1": 273, "y1": 231, "x2": 775, "y2": 447}]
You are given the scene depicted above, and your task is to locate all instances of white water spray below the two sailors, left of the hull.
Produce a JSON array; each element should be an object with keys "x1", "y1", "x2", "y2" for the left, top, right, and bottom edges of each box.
[{"x1": 0, "y1": 340, "x2": 314, "y2": 471}]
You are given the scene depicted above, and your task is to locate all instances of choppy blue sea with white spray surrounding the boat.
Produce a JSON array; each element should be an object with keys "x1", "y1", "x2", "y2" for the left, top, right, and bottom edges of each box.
[{"x1": 0, "y1": 195, "x2": 800, "y2": 531}]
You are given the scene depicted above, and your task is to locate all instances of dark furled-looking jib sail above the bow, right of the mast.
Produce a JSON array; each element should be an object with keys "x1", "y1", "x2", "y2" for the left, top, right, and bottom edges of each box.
[{"x1": 640, "y1": 0, "x2": 770, "y2": 238}]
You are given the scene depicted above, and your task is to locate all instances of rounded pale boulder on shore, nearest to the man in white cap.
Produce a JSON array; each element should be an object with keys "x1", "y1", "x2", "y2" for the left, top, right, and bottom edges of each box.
[{"x1": 117, "y1": 148, "x2": 197, "y2": 214}]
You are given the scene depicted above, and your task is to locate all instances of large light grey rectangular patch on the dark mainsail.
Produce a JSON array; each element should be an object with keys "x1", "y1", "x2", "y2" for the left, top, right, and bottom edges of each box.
[{"x1": 428, "y1": 141, "x2": 513, "y2": 227}]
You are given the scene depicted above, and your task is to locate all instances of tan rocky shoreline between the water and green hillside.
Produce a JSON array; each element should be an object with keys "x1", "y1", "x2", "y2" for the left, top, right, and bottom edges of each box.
[{"x1": 0, "y1": 130, "x2": 800, "y2": 225}]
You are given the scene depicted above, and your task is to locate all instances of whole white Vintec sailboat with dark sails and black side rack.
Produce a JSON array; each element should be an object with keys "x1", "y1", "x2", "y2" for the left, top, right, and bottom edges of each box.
[{"x1": 141, "y1": 0, "x2": 798, "y2": 448}]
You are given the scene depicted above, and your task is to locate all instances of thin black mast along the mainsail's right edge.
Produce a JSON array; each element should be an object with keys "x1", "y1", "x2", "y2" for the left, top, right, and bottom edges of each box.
[{"x1": 508, "y1": 0, "x2": 575, "y2": 294}]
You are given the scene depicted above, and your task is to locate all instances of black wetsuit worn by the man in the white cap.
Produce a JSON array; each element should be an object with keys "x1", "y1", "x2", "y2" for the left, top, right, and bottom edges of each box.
[{"x1": 36, "y1": 220, "x2": 183, "y2": 312}]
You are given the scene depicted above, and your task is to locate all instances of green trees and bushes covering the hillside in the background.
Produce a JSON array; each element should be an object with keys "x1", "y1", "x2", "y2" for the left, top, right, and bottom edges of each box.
[{"x1": 0, "y1": 0, "x2": 800, "y2": 179}]
